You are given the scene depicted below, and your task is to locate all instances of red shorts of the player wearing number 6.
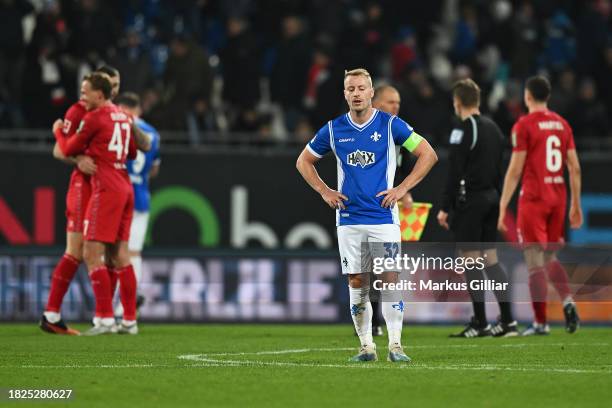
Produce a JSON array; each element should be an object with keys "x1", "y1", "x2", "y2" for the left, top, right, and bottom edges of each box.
[{"x1": 517, "y1": 198, "x2": 566, "y2": 249}]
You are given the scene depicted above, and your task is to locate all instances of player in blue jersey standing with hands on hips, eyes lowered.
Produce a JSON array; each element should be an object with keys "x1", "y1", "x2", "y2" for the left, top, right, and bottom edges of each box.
[{"x1": 297, "y1": 68, "x2": 438, "y2": 362}]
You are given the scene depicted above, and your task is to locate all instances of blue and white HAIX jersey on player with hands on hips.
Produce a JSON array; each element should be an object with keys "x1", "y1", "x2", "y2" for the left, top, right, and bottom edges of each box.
[{"x1": 307, "y1": 109, "x2": 418, "y2": 225}]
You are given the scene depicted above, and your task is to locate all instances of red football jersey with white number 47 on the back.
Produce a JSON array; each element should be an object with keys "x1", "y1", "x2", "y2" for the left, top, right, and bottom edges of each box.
[{"x1": 56, "y1": 103, "x2": 136, "y2": 191}]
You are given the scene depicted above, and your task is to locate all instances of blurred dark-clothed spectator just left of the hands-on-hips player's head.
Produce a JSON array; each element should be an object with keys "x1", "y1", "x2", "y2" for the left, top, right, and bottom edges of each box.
[{"x1": 270, "y1": 16, "x2": 312, "y2": 132}]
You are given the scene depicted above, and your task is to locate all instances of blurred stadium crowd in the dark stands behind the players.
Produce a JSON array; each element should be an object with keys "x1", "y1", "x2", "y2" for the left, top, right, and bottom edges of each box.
[{"x1": 0, "y1": 0, "x2": 612, "y2": 148}]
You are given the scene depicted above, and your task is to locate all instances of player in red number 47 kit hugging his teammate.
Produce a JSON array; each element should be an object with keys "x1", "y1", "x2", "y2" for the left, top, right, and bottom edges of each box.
[{"x1": 53, "y1": 73, "x2": 138, "y2": 335}]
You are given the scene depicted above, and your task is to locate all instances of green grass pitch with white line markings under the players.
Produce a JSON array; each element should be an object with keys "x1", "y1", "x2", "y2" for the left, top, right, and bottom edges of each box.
[{"x1": 0, "y1": 324, "x2": 612, "y2": 408}]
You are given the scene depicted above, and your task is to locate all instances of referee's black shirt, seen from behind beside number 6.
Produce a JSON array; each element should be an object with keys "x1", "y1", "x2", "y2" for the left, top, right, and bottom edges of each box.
[{"x1": 442, "y1": 115, "x2": 504, "y2": 212}]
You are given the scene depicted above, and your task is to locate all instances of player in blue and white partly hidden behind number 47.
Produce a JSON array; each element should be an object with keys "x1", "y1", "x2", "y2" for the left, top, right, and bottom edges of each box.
[{"x1": 115, "y1": 92, "x2": 161, "y2": 322}]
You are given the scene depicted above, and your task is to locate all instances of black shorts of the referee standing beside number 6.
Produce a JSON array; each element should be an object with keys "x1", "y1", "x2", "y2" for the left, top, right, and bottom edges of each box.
[{"x1": 451, "y1": 189, "x2": 500, "y2": 250}]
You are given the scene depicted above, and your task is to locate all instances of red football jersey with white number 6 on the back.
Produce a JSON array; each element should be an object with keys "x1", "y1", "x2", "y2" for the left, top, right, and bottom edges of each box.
[{"x1": 512, "y1": 110, "x2": 576, "y2": 204}]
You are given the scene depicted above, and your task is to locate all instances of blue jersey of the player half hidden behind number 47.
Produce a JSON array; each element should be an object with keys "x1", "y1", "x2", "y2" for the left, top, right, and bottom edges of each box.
[{"x1": 127, "y1": 118, "x2": 160, "y2": 212}]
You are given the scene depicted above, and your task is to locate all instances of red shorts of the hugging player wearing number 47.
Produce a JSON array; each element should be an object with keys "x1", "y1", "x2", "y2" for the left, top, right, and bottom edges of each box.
[{"x1": 83, "y1": 183, "x2": 134, "y2": 244}]
